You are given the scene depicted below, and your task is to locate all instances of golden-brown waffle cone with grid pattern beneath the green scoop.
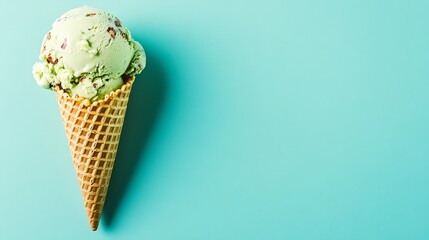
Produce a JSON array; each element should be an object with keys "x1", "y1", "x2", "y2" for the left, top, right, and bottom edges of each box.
[{"x1": 55, "y1": 77, "x2": 134, "y2": 231}]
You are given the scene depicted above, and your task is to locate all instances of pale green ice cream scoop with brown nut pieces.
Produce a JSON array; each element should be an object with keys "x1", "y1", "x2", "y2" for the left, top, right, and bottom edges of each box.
[{"x1": 33, "y1": 6, "x2": 146, "y2": 101}]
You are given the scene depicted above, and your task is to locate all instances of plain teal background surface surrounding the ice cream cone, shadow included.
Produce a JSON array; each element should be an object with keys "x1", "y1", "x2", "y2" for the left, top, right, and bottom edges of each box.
[{"x1": 0, "y1": 0, "x2": 429, "y2": 240}]
